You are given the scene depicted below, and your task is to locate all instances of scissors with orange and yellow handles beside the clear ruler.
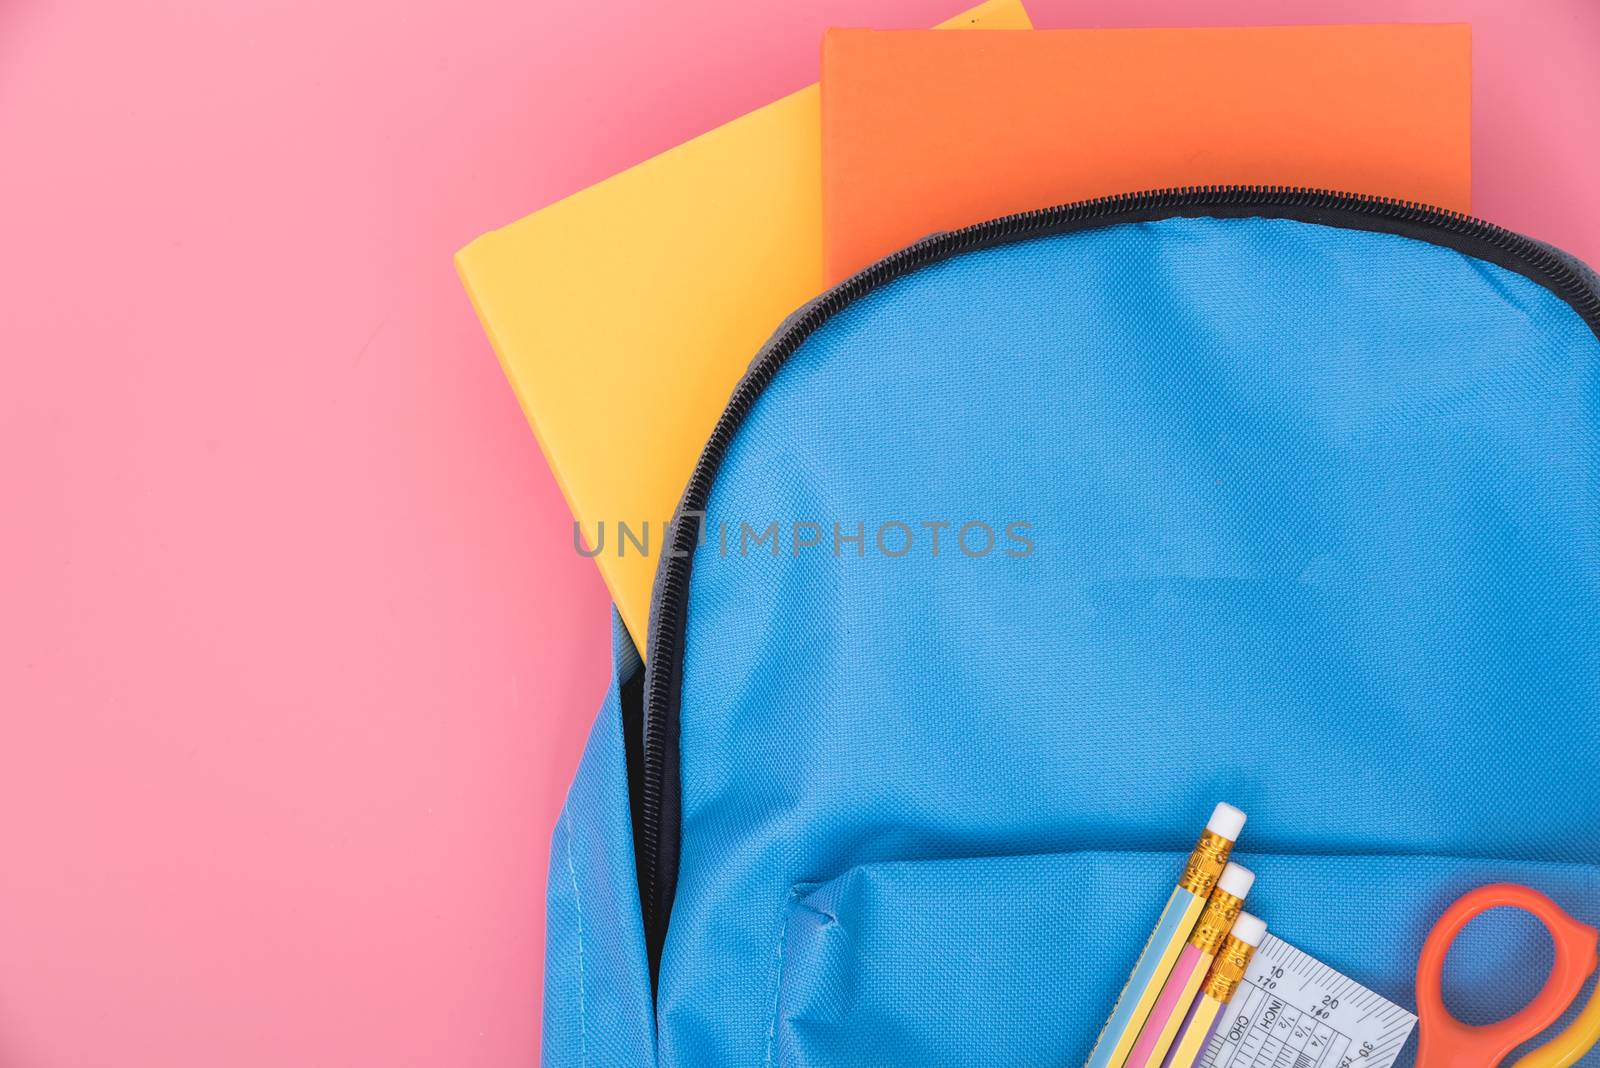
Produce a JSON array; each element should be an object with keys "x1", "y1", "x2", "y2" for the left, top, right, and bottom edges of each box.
[{"x1": 1416, "y1": 883, "x2": 1600, "y2": 1068}]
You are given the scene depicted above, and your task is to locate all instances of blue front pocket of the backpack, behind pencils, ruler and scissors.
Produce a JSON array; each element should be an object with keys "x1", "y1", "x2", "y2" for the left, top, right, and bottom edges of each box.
[{"x1": 768, "y1": 852, "x2": 1600, "y2": 1068}]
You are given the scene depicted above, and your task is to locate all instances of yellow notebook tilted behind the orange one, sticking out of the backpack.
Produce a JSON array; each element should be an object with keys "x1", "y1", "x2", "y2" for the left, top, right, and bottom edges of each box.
[{"x1": 456, "y1": 0, "x2": 1032, "y2": 649}]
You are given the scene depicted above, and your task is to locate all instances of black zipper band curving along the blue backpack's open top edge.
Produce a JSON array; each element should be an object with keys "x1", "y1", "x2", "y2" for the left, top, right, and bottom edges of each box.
[{"x1": 630, "y1": 185, "x2": 1600, "y2": 988}]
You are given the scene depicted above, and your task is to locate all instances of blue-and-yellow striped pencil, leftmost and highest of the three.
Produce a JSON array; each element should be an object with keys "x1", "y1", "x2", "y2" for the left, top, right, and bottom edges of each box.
[{"x1": 1085, "y1": 804, "x2": 1245, "y2": 1068}]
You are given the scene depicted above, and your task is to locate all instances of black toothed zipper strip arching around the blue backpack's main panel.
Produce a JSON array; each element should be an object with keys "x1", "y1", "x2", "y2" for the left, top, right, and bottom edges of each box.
[{"x1": 640, "y1": 185, "x2": 1600, "y2": 970}]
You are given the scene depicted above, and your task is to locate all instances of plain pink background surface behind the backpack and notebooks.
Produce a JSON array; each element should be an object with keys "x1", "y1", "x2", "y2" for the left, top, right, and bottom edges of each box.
[{"x1": 0, "y1": 0, "x2": 1600, "y2": 1068}]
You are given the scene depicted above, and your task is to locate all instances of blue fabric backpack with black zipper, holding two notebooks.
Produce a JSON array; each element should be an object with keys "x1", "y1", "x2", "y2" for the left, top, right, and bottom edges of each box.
[{"x1": 544, "y1": 189, "x2": 1600, "y2": 1068}]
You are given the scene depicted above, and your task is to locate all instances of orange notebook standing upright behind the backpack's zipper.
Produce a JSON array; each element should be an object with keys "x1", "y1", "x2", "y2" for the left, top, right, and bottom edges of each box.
[{"x1": 822, "y1": 26, "x2": 1472, "y2": 283}]
